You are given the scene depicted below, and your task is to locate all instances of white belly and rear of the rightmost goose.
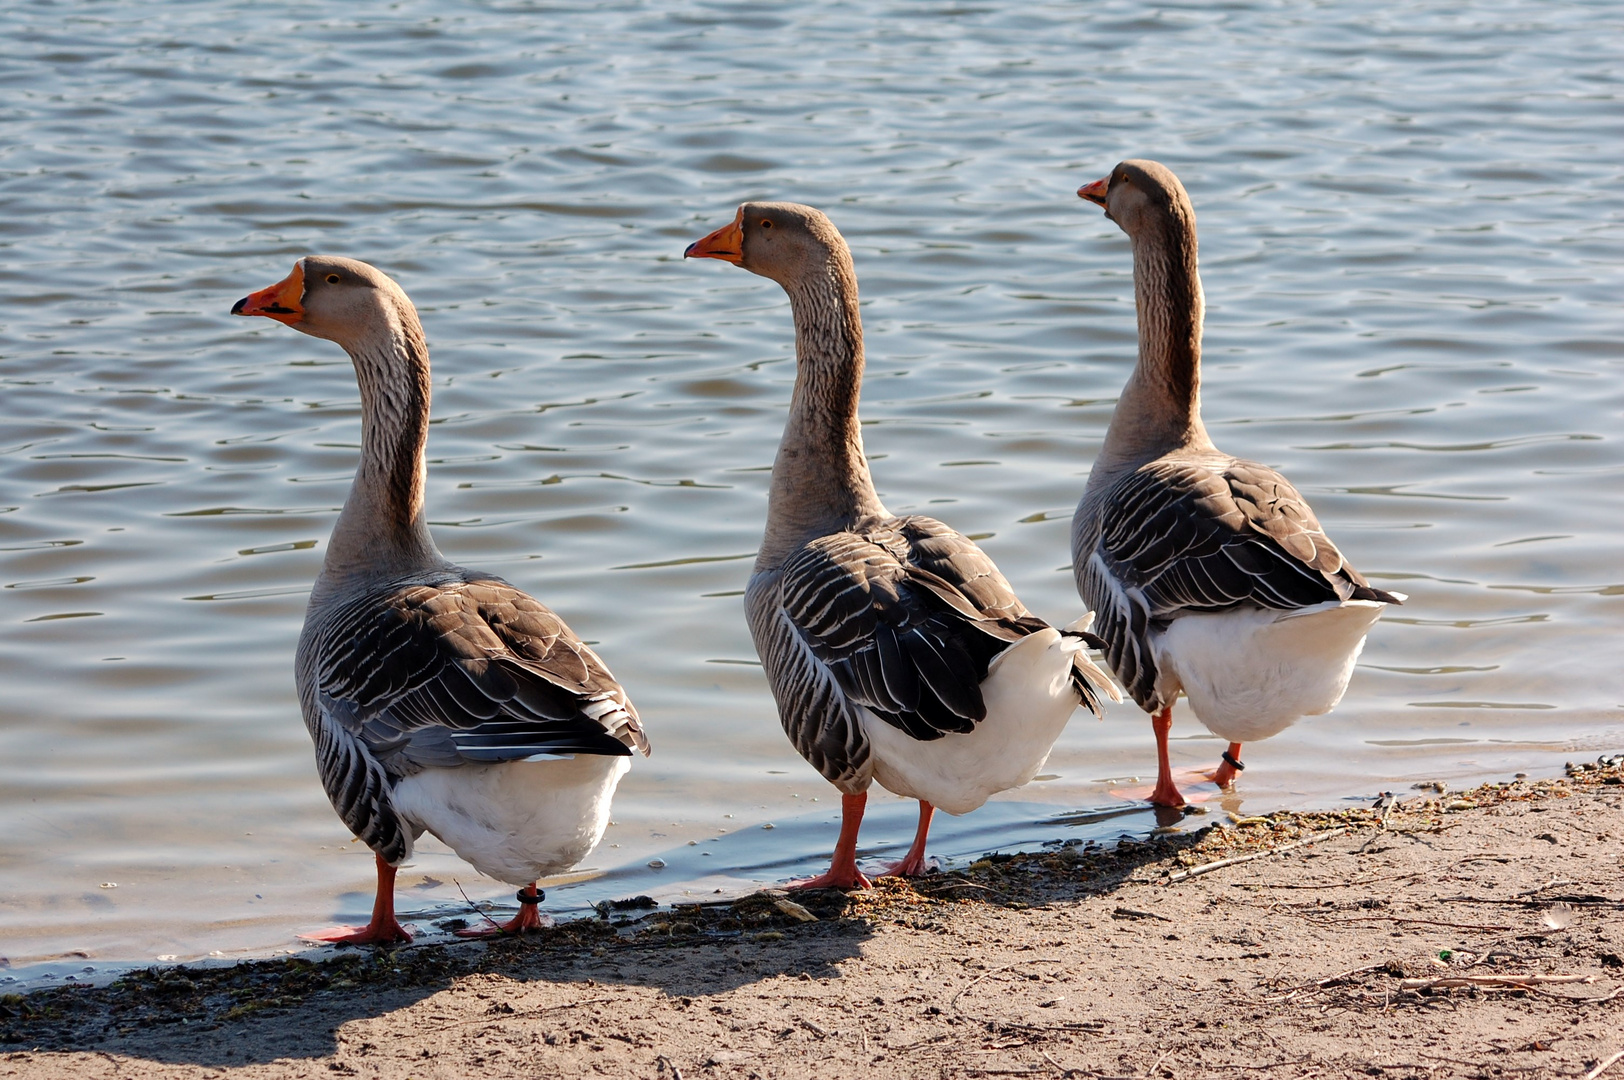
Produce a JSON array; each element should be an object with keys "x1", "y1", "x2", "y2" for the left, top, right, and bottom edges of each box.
[{"x1": 1150, "y1": 599, "x2": 1387, "y2": 742}]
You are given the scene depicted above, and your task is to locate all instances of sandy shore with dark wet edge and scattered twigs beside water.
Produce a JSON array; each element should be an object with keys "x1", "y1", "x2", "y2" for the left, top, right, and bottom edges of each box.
[{"x1": 0, "y1": 755, "x2": 1624, "y2": 1080}]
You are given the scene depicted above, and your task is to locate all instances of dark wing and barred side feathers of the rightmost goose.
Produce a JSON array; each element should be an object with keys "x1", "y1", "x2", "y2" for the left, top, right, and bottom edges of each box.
[{"x1": 1075, "y1": 460, "x2": 1398, "y2": 710}]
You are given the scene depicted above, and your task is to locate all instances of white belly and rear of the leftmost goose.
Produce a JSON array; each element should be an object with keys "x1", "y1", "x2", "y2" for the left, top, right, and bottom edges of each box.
[{"x1": 390, "y1": 754, "x2": 632, "y2": 885}]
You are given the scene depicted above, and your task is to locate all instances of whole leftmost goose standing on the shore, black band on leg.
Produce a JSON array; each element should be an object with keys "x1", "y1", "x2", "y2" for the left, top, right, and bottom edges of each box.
[{"x1": 231, "y1": 255, "x2": 648, "y2": 944}]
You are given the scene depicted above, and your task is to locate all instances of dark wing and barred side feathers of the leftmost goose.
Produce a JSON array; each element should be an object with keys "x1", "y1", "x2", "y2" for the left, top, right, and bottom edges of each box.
[{"x1": 300, "y1": 572, "x2": 648, "y2": 858}]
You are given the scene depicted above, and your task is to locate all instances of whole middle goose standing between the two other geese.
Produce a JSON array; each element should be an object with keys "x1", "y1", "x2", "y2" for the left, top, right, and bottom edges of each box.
[{"x1": 685, "y1": 203, "x2": 1121, "y2": 888}]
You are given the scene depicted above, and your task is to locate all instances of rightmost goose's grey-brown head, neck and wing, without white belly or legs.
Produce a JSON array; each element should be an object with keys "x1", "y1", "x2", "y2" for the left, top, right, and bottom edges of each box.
[{"x1": 1072, "y1": 161, "x2": 1402, "y2": 713}]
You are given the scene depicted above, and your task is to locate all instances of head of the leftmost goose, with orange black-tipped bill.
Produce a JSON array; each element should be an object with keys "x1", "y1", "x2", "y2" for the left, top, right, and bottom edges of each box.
[{"x1": 231, "y1": 255, "x2": 416, "y2": 351}]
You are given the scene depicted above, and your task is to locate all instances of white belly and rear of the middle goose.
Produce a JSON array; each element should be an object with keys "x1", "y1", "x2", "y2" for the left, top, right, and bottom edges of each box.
[{"x1": 862, "y1": 629, "x2": 1082, "y2": 814}]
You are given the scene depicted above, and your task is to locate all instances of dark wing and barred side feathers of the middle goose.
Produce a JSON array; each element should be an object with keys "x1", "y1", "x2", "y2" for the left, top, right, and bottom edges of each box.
[{"x1": 745, "y1": 516, "x2": 1103, "y2": 793}]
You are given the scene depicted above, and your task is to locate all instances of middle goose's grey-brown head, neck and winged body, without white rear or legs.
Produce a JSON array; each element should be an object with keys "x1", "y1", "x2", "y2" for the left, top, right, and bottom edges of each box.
[{"x1": 689, "y1": 203, "x2": 1109, "y2": 794}]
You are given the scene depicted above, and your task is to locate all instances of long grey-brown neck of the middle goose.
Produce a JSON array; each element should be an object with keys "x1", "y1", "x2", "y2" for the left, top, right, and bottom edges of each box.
[{"x1": 755, "y1": 252, "x2": 885, "y2": 570}]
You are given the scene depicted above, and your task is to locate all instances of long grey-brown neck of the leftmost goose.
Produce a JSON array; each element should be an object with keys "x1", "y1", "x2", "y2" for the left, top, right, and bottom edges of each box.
[{"x1": 323, "y1": 312, "x2": 445, "y2": 578}]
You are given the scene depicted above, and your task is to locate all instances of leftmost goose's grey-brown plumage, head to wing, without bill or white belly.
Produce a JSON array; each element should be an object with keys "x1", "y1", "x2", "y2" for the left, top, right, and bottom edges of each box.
[{"x1": 259, "y1": 257, "x2": 648, "y2": 864}]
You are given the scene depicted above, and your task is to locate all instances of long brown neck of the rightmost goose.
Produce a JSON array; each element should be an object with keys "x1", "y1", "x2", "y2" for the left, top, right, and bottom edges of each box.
[{"x1": 1096, "y1": 214, "x2": 1212, "y2": 468}]
